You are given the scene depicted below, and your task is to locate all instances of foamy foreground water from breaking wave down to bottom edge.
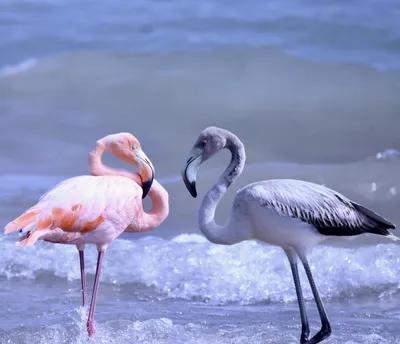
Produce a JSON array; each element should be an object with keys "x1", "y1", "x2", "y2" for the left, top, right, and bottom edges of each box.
[{"x1": 0, "y1": 234, "x2": 400, "y2": 343}]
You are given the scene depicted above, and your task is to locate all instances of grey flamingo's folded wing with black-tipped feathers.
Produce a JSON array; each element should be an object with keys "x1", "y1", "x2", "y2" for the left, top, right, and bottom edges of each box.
[{"x1": 239, "y1": 179, "x2": 395, "y2": 236}]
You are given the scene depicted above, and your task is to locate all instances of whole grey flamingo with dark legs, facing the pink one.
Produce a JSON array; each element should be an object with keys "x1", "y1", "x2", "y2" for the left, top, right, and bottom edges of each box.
[{"x1": 182, "y1": 127, "x2": 399, "y2": 344}]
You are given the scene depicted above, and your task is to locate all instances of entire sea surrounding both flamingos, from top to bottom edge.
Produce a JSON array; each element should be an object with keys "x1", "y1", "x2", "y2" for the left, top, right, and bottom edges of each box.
[{"x1": 0, "y1": 0, "x2": 400, "y2": 344}]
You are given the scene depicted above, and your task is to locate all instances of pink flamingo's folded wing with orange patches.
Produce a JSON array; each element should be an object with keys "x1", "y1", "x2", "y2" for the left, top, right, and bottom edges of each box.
[{"x1": 5, "y1": 176, "x2": 142, "y2": 244}]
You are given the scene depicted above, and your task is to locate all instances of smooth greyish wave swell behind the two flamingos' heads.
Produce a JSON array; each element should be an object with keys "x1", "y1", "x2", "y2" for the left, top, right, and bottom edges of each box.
[{"x1": 0, "y1": 48, "x2": 400, "y2": 171}]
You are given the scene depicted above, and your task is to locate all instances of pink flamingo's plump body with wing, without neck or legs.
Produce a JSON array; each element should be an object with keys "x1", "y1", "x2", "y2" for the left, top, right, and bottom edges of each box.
[{"x1": 6, "y1": 176, "x2": 143, "y2": 246}]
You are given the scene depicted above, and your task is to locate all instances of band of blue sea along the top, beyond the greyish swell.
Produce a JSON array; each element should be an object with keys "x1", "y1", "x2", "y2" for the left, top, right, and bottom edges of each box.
[{"x1": 1, "y1": 0, "x2": 400, "y2": 71}]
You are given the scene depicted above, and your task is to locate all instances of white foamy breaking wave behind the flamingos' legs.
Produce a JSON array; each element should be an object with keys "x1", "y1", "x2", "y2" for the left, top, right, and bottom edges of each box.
[{"x1": 0, "y1": 234, "x2": 400, "y2": 304}]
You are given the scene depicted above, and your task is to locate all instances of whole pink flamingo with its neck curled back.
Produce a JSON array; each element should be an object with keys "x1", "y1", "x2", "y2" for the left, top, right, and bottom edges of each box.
[{"x1": 4, "y1": 133, "x2": 169, "y2": 336}]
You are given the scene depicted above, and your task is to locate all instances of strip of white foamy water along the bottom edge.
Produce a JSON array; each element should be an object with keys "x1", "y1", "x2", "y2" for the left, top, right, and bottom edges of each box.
[{"x1": 0, "y1": 312, "x2": 399, "y2": 344}]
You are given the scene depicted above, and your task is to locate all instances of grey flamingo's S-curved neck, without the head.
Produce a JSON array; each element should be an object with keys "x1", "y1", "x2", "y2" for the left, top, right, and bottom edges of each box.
[{"x1": 199, "y1": 134, "x2": 246, "y2": 245}]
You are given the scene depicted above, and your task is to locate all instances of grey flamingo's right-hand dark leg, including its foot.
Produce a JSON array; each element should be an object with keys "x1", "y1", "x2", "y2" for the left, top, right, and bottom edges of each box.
[{"x1": 297, "y1": 252, "x2": 332, "y2": 344}]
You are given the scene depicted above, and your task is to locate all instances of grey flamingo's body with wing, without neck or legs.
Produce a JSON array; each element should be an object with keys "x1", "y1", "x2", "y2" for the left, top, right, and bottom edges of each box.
[{"x1": 231, "y1": 179, "x2": 396, "y2": 252}]
